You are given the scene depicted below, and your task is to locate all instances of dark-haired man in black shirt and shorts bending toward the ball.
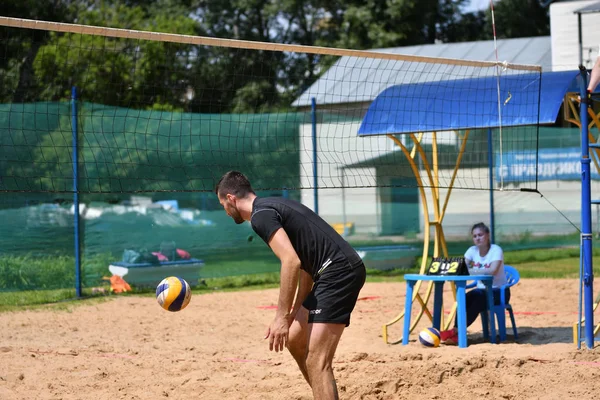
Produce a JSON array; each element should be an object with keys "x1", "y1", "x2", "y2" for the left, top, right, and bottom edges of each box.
[{"x1": 215, "y1": 171, "x2": 366, "y2": 399}]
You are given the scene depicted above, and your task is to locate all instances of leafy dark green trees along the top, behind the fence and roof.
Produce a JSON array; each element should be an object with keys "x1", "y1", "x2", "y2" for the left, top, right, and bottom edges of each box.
[{"x1": 0, "y1": 0, "x2": 549, "y2": 113}]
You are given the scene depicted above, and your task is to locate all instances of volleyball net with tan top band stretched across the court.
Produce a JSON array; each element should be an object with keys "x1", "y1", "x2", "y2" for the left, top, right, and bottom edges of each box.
[{"x1": 0, "y1": 18, "x2": 541, "y2": 193}]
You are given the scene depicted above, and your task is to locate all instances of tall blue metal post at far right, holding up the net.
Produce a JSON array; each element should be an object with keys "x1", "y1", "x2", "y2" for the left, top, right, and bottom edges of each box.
[{"x1": 579, "y1": 65, "x2": 594, "y2": 349}]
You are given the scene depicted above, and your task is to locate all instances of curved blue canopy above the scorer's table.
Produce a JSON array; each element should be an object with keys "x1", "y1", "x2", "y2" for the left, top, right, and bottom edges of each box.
[{"x1": 358, "y1": 71, "x2": 579, "y2": 136}]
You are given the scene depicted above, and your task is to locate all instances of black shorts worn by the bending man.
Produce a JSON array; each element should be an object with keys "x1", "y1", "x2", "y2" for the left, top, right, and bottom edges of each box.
[{"x1": 302, "y1": 263, "x2": 367, "y2": 326}]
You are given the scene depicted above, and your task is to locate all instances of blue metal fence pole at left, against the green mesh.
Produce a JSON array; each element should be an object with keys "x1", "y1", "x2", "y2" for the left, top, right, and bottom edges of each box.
[{"x1": 71, "y1": 86, "x2": 81, "y2": 297}]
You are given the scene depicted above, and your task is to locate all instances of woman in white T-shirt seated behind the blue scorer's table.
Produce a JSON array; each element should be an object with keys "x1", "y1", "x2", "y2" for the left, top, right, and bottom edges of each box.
[{"x1": 441, "y1": 222, "x2": 510, "y2": 345}]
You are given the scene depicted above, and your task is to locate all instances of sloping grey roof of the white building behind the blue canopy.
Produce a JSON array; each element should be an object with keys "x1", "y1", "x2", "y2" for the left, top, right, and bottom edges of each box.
[{"x1": 292, "y1": 36, "x2": 552, "y2": 107}]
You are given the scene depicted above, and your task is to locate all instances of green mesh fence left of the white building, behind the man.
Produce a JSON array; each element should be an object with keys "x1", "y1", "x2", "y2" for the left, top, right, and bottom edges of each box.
[{"x1": 0, "y1": 103, "x2": 310, "y2": 290}]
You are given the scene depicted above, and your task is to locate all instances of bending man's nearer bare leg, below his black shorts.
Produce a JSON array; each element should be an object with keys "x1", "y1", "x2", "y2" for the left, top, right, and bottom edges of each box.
[{"x1": 306, "y1": 323, "x2": 346, "y2": 400}]
